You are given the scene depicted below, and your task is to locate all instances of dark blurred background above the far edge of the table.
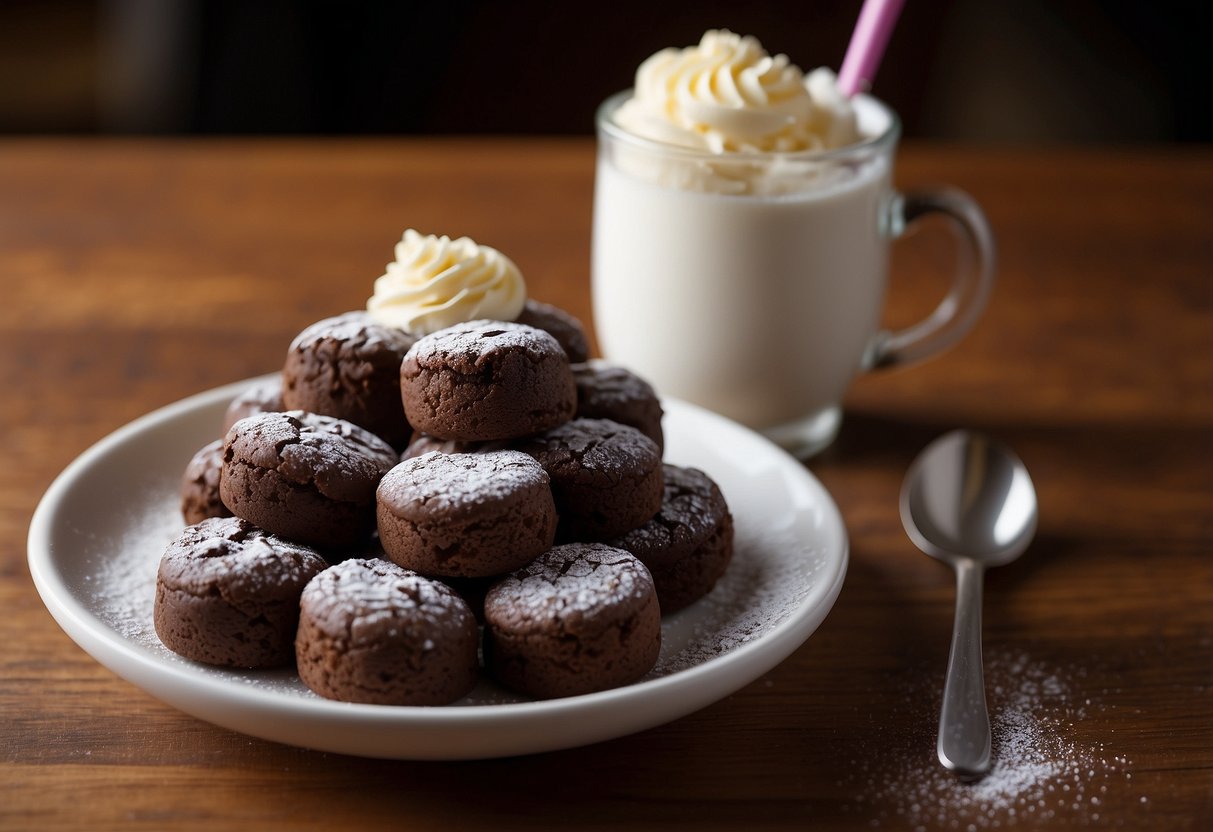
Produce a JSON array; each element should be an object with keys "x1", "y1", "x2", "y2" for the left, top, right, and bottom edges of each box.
[{"x1": 0, "y1": 0, "x2": 1213, "y2": 143}]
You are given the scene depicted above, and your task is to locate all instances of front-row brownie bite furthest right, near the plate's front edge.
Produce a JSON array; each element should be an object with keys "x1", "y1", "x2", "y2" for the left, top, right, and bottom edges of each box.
[{"x1": 484, "y1": 543, "x2": 661, "y2": 699}]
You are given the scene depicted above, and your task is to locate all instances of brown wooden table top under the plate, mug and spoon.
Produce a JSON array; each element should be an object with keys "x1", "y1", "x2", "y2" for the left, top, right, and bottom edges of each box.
[{"x1": 0, "y1": 139, "x2": 1213, "y2": 832}]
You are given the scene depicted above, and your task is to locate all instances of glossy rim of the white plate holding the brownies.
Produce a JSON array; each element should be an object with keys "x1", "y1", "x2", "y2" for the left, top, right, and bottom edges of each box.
[{"x1": 27, "y1": 374, "x2": 850, "y2": 759}]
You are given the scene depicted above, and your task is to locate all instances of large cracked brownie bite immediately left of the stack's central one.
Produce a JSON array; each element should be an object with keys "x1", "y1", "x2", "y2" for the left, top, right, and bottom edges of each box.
[{"x1": 220, "y1": 410, "x2": 398, "y2": 551}]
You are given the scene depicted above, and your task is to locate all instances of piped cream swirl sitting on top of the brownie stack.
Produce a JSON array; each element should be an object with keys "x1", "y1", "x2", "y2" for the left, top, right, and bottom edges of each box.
[{"x1": 366, "y1": 228, "x2": 526, "y2": 335}]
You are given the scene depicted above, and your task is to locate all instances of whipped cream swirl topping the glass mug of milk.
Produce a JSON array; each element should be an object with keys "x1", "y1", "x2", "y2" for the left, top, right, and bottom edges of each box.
[{"x1": 615, "y1": 29, "x2": 859, "y2": 153}]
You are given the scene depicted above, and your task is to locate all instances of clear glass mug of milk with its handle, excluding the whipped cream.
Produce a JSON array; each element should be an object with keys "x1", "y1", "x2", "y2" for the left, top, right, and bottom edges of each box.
[{"x1": 592, "y1": 92, "x2": 993, "y2": 458}]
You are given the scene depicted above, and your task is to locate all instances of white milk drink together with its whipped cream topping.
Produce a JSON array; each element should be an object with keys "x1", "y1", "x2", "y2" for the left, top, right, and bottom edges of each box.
[{"x1": 593, "y1": 32, "x2": 896, "y2": 436}]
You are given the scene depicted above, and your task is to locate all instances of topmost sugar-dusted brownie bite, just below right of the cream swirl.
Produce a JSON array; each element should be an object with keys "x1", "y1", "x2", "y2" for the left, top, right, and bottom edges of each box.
[{"x1": 400, "y1": 320, "x2": 577, "y2": 440}]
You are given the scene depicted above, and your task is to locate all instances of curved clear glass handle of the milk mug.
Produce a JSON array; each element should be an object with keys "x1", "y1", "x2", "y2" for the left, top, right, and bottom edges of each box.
[{"x1": 869, "y1": 189, "x2": 995, "y2": 369}]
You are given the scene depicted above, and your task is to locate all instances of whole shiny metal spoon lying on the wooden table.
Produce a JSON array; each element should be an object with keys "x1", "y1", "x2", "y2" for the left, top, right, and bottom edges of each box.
[{"x1": 901, "y1": 431, "x2": 1036, "y2": 779}]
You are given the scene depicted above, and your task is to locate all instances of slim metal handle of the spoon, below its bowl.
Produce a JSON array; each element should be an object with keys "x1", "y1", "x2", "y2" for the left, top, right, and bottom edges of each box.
[{"x1": 938, "y1": 559, "x2": 990, "y2": 777}]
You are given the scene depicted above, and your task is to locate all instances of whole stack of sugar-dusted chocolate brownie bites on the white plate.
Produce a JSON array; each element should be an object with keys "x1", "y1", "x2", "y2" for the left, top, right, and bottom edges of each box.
[{"x1": 154, "y1": 232, "x2": 733, "y2": 705}]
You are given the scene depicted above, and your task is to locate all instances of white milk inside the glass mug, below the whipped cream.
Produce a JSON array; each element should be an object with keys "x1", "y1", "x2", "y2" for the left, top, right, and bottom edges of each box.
[{"x1": 593, "y1": 100, "x2": 890, "y2": 428}]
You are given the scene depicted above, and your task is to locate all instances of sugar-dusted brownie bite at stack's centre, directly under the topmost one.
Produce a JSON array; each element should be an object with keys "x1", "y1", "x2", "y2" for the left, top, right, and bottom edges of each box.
[{"x1": 377, "y1": 451, "x2": 556, "y2": 577}]
